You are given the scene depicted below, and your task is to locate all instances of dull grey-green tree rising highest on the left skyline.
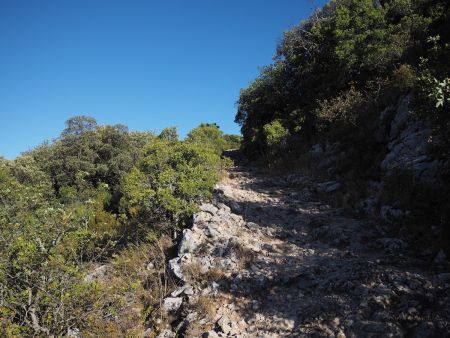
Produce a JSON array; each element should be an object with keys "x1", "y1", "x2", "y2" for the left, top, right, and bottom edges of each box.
[{"x1": 25, "y1": 116, "x2": 154, "y2": 212}]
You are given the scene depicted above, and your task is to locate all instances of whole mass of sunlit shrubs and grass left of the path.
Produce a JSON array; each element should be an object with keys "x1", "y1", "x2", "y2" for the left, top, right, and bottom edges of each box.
[{"x1": 0, "y1": 116, "x2": 236, "y2": 337}]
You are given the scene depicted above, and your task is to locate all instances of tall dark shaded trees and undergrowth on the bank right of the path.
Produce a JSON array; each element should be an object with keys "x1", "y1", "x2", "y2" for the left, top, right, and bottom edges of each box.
[{"x1": 235, "y1": 0, "x2": 450, "y2": 246}]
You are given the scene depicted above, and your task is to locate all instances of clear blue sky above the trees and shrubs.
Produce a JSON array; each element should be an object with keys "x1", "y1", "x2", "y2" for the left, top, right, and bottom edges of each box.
[{"x1": 0, "y1": 0, "x2": 325, "y2": 159}]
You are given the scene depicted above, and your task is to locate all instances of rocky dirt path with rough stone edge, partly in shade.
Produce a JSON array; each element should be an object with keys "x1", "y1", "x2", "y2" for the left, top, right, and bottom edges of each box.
[{"x1": 160, "y1": 167, "x2": 450, "y2": 338}]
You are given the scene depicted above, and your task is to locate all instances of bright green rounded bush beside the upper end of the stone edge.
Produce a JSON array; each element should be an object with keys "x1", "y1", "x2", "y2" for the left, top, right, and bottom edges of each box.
[{"x1": 122, "y1": 139, "x2": 220, "y2": 226}]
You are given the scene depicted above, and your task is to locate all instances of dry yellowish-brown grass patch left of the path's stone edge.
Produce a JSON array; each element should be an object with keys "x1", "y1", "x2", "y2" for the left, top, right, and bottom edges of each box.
[{"x1": 83, "y1": 237, "x2": 176, "y2": 337}]
